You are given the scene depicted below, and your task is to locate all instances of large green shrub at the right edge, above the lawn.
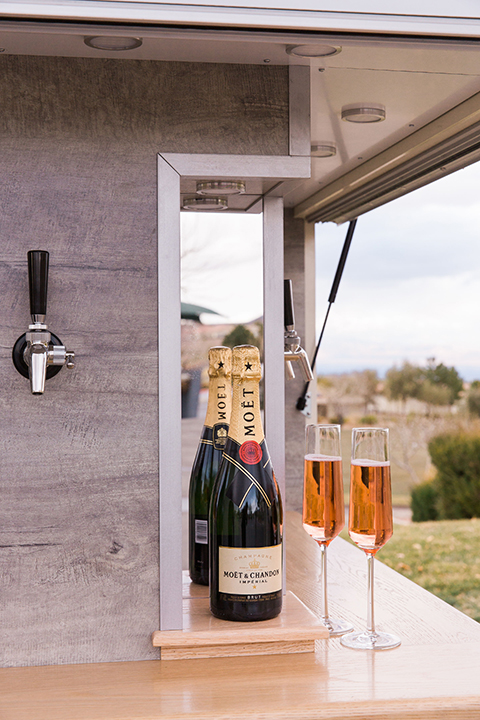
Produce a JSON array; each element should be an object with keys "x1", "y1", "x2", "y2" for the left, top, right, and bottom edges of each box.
[{"x1": 428, "y1": 433, "x2": 480, "y2": 520}]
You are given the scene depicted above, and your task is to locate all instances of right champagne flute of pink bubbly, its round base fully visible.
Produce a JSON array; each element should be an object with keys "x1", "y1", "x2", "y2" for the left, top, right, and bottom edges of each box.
[{"x1": 341, "y1": 428, "x2": 401, "y2": 650}]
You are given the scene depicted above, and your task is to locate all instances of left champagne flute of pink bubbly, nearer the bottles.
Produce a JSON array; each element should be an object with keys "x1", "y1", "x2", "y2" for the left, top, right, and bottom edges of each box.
[{"x1": 303, "y1": 425, "x2": 353, "y2": 636}]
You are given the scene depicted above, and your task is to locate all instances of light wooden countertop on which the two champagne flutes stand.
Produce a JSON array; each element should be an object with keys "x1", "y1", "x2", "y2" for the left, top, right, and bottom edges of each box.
[{"x1": 0, "y1": 513, "x2": 480, "y2": 720}]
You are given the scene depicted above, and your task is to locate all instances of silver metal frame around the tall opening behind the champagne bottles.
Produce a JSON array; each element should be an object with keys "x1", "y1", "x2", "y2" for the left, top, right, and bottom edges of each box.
[{"x1": 157, "y1": 152, "x2": 310, "y2": 630}]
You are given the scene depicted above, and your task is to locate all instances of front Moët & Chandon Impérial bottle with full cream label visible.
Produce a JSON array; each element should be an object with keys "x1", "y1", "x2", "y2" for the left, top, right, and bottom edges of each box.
[{"x1": 209, "y1": 345, "x2": 282, "y2": 621}]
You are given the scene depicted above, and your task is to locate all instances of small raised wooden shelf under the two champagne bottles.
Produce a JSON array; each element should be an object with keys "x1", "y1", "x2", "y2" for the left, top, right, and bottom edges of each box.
[{"x1": 152, "y1": 574, "x2": 328, "y2": 660}]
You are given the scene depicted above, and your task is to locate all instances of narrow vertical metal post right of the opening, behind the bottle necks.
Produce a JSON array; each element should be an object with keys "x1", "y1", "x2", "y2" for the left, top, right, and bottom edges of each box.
[{"x1": 263, "y1": 197, "x2": 285, "y2": 588}]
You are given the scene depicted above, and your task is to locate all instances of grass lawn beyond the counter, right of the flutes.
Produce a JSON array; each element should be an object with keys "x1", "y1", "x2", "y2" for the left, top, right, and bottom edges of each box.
[{"x1": 341, "y1": 518, "x2": 480, "y2": 622}]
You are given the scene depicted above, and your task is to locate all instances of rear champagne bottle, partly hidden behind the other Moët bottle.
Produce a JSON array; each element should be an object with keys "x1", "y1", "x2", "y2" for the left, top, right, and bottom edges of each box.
[{"x1": 189, "y1": 347, "x2": 232, "y2": 585}]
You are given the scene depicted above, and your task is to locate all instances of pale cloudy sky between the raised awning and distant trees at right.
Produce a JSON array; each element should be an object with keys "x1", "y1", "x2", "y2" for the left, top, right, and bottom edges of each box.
[{"x1": 316, "y1": 166, "x2": 480, "y2": 379}]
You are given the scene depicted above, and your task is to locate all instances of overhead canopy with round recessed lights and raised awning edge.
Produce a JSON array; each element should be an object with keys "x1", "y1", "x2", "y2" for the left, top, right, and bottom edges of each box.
[{"x1": 0, "y1": 6, "x2": 480, "y2": 223}]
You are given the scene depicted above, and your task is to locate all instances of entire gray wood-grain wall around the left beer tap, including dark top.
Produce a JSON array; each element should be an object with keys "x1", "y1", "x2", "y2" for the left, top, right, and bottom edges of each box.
[{"x1": 0, "y1": 56, "x2": 288, "y2": 666}]
